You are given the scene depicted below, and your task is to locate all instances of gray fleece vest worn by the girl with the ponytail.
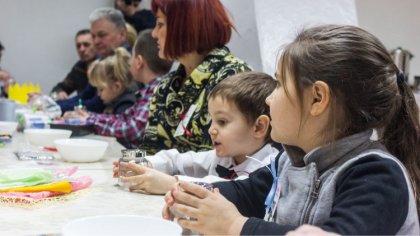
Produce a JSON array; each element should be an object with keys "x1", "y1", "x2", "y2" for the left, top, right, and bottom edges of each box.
[{"x1": 275, "y1": 132, "x2": 420, "y2": 235}]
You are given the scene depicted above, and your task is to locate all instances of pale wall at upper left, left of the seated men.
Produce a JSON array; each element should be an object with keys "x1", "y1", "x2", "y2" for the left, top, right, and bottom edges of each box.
[{"x1": 0, "y1": 0, "x2": 113, "y2": 93}]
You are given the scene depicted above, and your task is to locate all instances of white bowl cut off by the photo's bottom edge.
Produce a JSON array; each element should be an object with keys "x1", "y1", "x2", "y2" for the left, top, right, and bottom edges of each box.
[{"x1": 61, "y1": 215, "x2": 182, "y2": 236}]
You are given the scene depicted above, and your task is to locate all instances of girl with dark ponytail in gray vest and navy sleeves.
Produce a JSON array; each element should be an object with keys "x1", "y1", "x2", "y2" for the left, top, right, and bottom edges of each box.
[{"x1": 162, "y1": 25, "x2": 420, "y2": 235}]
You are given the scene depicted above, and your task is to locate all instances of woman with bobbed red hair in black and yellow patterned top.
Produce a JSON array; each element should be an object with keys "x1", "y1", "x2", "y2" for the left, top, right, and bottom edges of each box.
[{"x1": 141, "y1": 0, "x2": 251, "y2": 155}]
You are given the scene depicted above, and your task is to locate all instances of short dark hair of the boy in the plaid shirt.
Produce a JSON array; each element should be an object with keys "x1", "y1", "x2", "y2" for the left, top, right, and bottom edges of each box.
[{"x1": 133, "y1": 29, "x2": 172, "y2": 74}]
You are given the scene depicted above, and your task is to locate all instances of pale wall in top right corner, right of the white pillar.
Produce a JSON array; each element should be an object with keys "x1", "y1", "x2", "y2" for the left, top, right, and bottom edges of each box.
[{"x1": 356, "y1": 0, "x2": 420, "y2": 85}]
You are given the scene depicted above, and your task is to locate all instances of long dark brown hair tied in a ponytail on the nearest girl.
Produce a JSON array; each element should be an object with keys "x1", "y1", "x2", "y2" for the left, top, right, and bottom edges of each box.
[{"x1": 278, "y1": 25, "x2": 420, "y2": 216}]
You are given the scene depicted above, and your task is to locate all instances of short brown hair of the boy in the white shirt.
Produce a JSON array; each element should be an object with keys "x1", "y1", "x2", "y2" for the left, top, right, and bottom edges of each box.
[{"x1": 208, "y1": 71, "x2": 276, "y2": 139}]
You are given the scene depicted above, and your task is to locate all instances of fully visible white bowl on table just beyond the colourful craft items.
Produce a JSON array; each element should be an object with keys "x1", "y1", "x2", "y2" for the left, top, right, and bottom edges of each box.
[{"x1": 55, "y1": 138, "x2": 108, "y2": 162}]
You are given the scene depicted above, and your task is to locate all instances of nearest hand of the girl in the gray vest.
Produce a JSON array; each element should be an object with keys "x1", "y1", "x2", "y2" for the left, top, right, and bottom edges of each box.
[{"x1": 169, "y1": 182, "x2": 247, "y2": 235}]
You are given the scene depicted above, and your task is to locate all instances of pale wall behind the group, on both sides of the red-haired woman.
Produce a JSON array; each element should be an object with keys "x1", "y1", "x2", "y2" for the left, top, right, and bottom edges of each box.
[{"x1": 0, "y1": 0, "x2": 261, "y2": 93}]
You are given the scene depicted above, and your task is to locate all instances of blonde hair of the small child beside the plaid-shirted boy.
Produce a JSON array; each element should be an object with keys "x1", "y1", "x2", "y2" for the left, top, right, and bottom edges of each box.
[{"x1": 88, "y1": 47, "x2": 133, "y2": 89}]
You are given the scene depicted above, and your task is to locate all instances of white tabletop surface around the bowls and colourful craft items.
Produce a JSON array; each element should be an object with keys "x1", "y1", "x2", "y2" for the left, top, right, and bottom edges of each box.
[{"x1": 0, "y1": 133, "x2": 164, "y2": 235}]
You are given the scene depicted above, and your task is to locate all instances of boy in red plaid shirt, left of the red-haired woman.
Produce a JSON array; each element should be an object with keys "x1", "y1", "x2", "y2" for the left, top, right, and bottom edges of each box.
[{"x1": 87, "y1": 30, "x2": 172, "y2": 148}]
